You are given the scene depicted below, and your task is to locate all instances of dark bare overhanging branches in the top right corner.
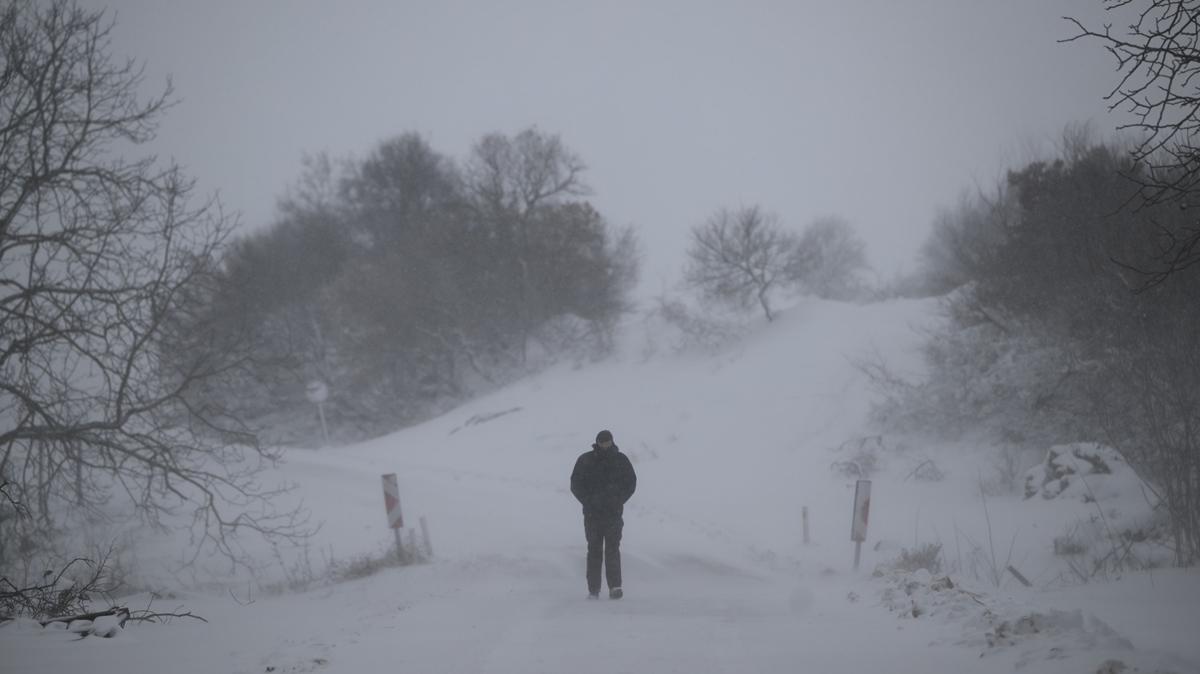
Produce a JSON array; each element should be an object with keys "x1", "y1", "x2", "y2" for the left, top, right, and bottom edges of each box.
[{"x1": 1063, "y1": 0, "x2": 1200, "y2": 284}]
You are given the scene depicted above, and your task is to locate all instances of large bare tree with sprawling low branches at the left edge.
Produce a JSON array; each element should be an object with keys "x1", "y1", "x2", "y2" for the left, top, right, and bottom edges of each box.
[{"x1": 0, "y1": 0, "x2": 304, "y2": 575}]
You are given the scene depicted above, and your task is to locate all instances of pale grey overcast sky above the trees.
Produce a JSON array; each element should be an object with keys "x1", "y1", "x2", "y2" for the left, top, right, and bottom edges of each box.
[{"x1": 86, "y1": 0, "x2": 1115, "y2": 285}]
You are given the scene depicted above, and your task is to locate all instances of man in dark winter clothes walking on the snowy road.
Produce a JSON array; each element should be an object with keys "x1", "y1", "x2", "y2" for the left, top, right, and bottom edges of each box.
[{"x1": 571, "y1": 431, "x2": 637, "y2": 600}]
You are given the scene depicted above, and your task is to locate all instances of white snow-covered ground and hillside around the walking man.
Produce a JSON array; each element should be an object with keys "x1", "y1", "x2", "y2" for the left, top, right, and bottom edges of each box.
[{"x1": 0, "y1": 301, "x2": 1200, "y2": 674}]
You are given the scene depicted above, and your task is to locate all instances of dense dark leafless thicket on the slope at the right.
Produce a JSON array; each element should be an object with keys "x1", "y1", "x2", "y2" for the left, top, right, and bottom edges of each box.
[{"x1": 902, "y1": 132, "x2": 1200, "y2": 566}]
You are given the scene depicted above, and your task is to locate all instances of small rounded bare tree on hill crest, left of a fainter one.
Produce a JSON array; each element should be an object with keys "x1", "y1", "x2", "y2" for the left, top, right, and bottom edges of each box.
[{"x1": 684, "y1": 206, "x2": 796, "y2": 321}]
